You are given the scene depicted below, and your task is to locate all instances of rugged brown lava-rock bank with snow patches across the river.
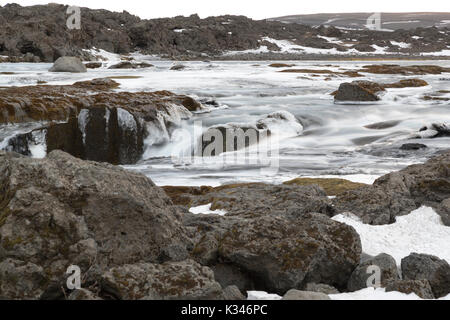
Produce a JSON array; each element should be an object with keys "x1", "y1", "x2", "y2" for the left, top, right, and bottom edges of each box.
[{"x1": 0, "y1": 4, "x2": 450, "y2": 62}]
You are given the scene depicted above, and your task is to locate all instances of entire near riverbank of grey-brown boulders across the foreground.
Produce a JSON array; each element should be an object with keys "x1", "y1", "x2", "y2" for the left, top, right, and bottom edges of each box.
[{"x1": 0, "y1": 151, "x2": 450, "y2": 299}]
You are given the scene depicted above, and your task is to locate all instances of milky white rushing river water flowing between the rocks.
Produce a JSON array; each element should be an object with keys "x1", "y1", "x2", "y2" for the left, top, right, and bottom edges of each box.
[{"x1": 0, "y1": 59, "x2": 450, "y2": 185}]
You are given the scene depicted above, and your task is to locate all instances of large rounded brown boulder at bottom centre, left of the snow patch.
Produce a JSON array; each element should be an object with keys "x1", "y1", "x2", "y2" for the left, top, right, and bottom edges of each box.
[{"x1": 185, "y1": 212, "x2": 361, "y2": 295}]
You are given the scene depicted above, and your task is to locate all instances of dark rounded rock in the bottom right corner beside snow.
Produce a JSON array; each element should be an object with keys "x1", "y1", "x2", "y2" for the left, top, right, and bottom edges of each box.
[{"x1": 402, "y1": 253, "x2": 450, "y2": 298}]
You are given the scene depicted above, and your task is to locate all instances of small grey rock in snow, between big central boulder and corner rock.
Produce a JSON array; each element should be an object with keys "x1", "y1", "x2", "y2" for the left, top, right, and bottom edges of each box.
[{"x1": 347, "y1": 253, "x2": 399, "y2": 292}]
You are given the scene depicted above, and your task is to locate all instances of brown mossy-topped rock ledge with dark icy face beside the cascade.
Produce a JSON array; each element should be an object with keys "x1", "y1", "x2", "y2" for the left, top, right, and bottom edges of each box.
[{"x1": 0, "y1": 79, "x2": 203, "y2": 164}]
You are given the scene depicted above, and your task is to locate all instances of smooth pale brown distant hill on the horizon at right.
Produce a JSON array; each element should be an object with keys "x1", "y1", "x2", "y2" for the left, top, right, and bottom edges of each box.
[{"x1": 268, "y1": 12, "x2": 450, "y2": 30}]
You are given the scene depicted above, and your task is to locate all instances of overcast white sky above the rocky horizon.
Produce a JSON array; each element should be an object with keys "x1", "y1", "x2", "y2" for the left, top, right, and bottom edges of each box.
[{"x1": 0, "y1": 0, "x2": 450, "y2": 19}]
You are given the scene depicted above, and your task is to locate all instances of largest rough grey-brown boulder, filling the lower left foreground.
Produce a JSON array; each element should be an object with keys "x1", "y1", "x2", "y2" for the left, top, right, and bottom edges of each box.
[{"x1": 0, "y1": 151, "x2": 189, "y2": 299}]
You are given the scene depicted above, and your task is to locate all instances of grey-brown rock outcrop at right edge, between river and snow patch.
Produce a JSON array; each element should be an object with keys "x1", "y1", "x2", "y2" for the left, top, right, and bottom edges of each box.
[{"x1": 333, "y1": 152, "x2": 450, "y2": 226}]
